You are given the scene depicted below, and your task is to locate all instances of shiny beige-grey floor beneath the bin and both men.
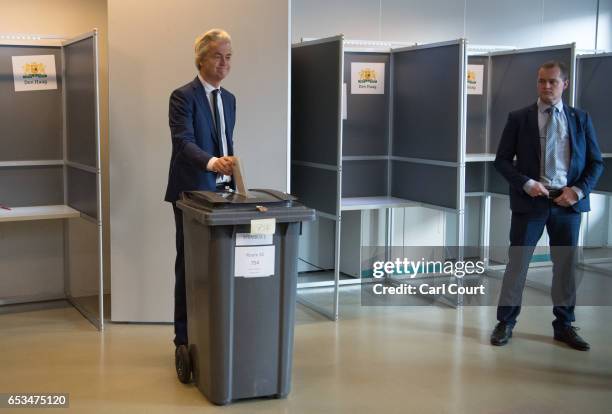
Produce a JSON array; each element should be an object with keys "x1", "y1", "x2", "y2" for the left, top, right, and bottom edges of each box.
[{"x1": 0, "y1": 270, "x2": 612, "y2": 414}]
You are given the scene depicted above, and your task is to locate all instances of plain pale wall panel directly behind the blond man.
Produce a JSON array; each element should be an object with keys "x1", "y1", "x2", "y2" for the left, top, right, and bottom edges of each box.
[{"x1": 108, "y1": 0, "x2": 290, "y2": 321}]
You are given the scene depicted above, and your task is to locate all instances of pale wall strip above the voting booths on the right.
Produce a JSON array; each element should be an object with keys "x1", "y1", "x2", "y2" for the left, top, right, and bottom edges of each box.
[{"x1": 292, "y1": 0, "x2": 612, "y2": 49}]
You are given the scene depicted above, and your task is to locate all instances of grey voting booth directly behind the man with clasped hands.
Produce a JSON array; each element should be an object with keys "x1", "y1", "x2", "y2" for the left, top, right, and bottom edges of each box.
[{"x1": 466, "y1": 43, "x2": 575, "y2": 270}]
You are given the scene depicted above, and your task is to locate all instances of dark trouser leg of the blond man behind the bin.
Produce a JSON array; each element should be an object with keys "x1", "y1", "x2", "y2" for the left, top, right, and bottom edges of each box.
[{"x1": 172, "y1": 203, "x2": 188, "y2": 346}]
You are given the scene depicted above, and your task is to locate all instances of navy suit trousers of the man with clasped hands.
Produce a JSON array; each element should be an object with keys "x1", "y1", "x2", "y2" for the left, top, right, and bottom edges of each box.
[{"x1": 497, "y1": 201, "x2": 581, "y2": 330}]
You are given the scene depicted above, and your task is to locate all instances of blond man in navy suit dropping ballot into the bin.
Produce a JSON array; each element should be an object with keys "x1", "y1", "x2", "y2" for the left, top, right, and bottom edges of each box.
[{"x1": 165, "y1": 29, "x2": 236, "y2": 349}]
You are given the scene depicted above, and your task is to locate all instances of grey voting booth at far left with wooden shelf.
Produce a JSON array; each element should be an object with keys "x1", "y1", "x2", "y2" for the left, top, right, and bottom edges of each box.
[{"x1": 0, "y1": 30, "x2": 104, "y2": 330}]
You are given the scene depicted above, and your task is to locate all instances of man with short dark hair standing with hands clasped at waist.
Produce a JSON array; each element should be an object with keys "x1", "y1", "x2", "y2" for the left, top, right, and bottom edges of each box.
[{"x1": 491, "y1": 61, "x2": 603, "y2": 351}]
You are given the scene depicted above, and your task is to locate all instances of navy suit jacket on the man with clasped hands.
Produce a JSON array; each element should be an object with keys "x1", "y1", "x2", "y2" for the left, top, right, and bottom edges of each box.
[{"x1": 495, "y1": 104, "x2": 603, "y2": 213}]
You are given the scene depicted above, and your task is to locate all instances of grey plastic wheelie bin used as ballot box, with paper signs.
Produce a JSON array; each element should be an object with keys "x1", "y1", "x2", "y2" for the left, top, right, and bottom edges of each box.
[{"x1": 177, "y1": 190, "x2": 315, "y2": 405}]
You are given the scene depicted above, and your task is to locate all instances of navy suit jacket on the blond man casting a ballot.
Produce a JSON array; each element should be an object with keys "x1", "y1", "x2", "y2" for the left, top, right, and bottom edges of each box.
[{"x1": 165, "y1": 77, "x2": 236, "y2": 202}]
